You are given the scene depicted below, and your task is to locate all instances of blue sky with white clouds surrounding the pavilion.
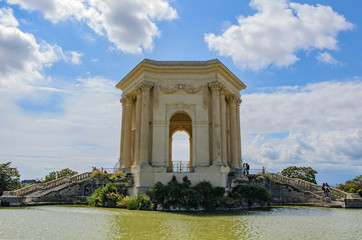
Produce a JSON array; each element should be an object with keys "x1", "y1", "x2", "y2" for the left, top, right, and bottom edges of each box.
[{"x1": 0, "y1": 0, "x2": 362, "y2": 185}]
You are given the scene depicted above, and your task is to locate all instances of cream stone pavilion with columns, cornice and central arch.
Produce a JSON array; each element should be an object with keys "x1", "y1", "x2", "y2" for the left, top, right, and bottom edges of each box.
[{"x1": 117, "y1": 59, "x2": 246, "y2": 194}]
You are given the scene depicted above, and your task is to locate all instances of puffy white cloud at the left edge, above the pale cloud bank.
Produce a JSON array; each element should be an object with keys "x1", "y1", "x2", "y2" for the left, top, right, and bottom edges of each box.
[{"x1": 0, "y1": 8, "x2": 80, "y2": 87}]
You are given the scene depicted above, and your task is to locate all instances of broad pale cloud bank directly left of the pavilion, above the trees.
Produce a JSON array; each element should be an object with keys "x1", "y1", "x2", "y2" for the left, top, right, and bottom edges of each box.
[{"x1": 0, "y1": 78, "x2": 121, "y2": 179}]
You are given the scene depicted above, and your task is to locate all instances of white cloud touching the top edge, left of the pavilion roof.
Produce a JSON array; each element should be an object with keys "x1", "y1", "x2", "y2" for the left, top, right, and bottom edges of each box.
[{"x1": 7, "y1": 0, "x2": 177, "y2": 54}]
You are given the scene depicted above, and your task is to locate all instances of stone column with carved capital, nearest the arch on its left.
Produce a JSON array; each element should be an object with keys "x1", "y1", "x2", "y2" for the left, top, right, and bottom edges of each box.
[{"x1": 139, "y1": 82, "x2": 153, "y2": 165}]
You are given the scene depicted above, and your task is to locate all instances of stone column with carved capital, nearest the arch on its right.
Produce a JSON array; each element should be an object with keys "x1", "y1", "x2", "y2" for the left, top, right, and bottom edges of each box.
[{"x1": 209, "y1": 82, "x2": 222, "y2": 166}]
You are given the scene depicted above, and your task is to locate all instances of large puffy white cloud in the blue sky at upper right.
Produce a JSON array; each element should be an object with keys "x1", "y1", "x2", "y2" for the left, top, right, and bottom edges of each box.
[{"x1": 205, "y1": 0, "x2": 353, "y2": 70}]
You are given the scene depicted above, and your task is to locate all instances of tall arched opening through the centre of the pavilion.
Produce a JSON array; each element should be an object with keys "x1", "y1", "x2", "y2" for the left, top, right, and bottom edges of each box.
[{"x1": 169, "y1": 113, "x2": 193, "y2": 172}]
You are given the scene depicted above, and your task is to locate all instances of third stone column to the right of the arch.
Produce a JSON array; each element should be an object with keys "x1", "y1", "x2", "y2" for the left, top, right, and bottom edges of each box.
[{"x1": 229, "y1": 95, "x2": 239, "y2": 168}]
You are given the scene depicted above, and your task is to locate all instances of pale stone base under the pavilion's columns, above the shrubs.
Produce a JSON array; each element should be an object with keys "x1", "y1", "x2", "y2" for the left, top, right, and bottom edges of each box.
[{"x1": 129, "y1": 164, "x2": 230, "y2": 195}]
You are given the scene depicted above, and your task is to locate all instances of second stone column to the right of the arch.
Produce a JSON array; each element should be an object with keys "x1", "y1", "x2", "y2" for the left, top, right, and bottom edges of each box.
[{"x1": 220, "y1": 90, "x2": 228, "y2": 167}]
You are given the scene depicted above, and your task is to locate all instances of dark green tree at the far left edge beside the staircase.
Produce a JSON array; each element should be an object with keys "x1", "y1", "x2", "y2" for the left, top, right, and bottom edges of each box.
[{"x1": 0, "y1": 162, "x2": 21, "y2": 196}]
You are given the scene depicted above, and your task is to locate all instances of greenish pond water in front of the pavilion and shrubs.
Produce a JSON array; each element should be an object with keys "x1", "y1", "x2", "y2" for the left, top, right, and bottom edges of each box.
[{"x1": 0, "y1": 206, "x2": 362, "y2": 240}]
